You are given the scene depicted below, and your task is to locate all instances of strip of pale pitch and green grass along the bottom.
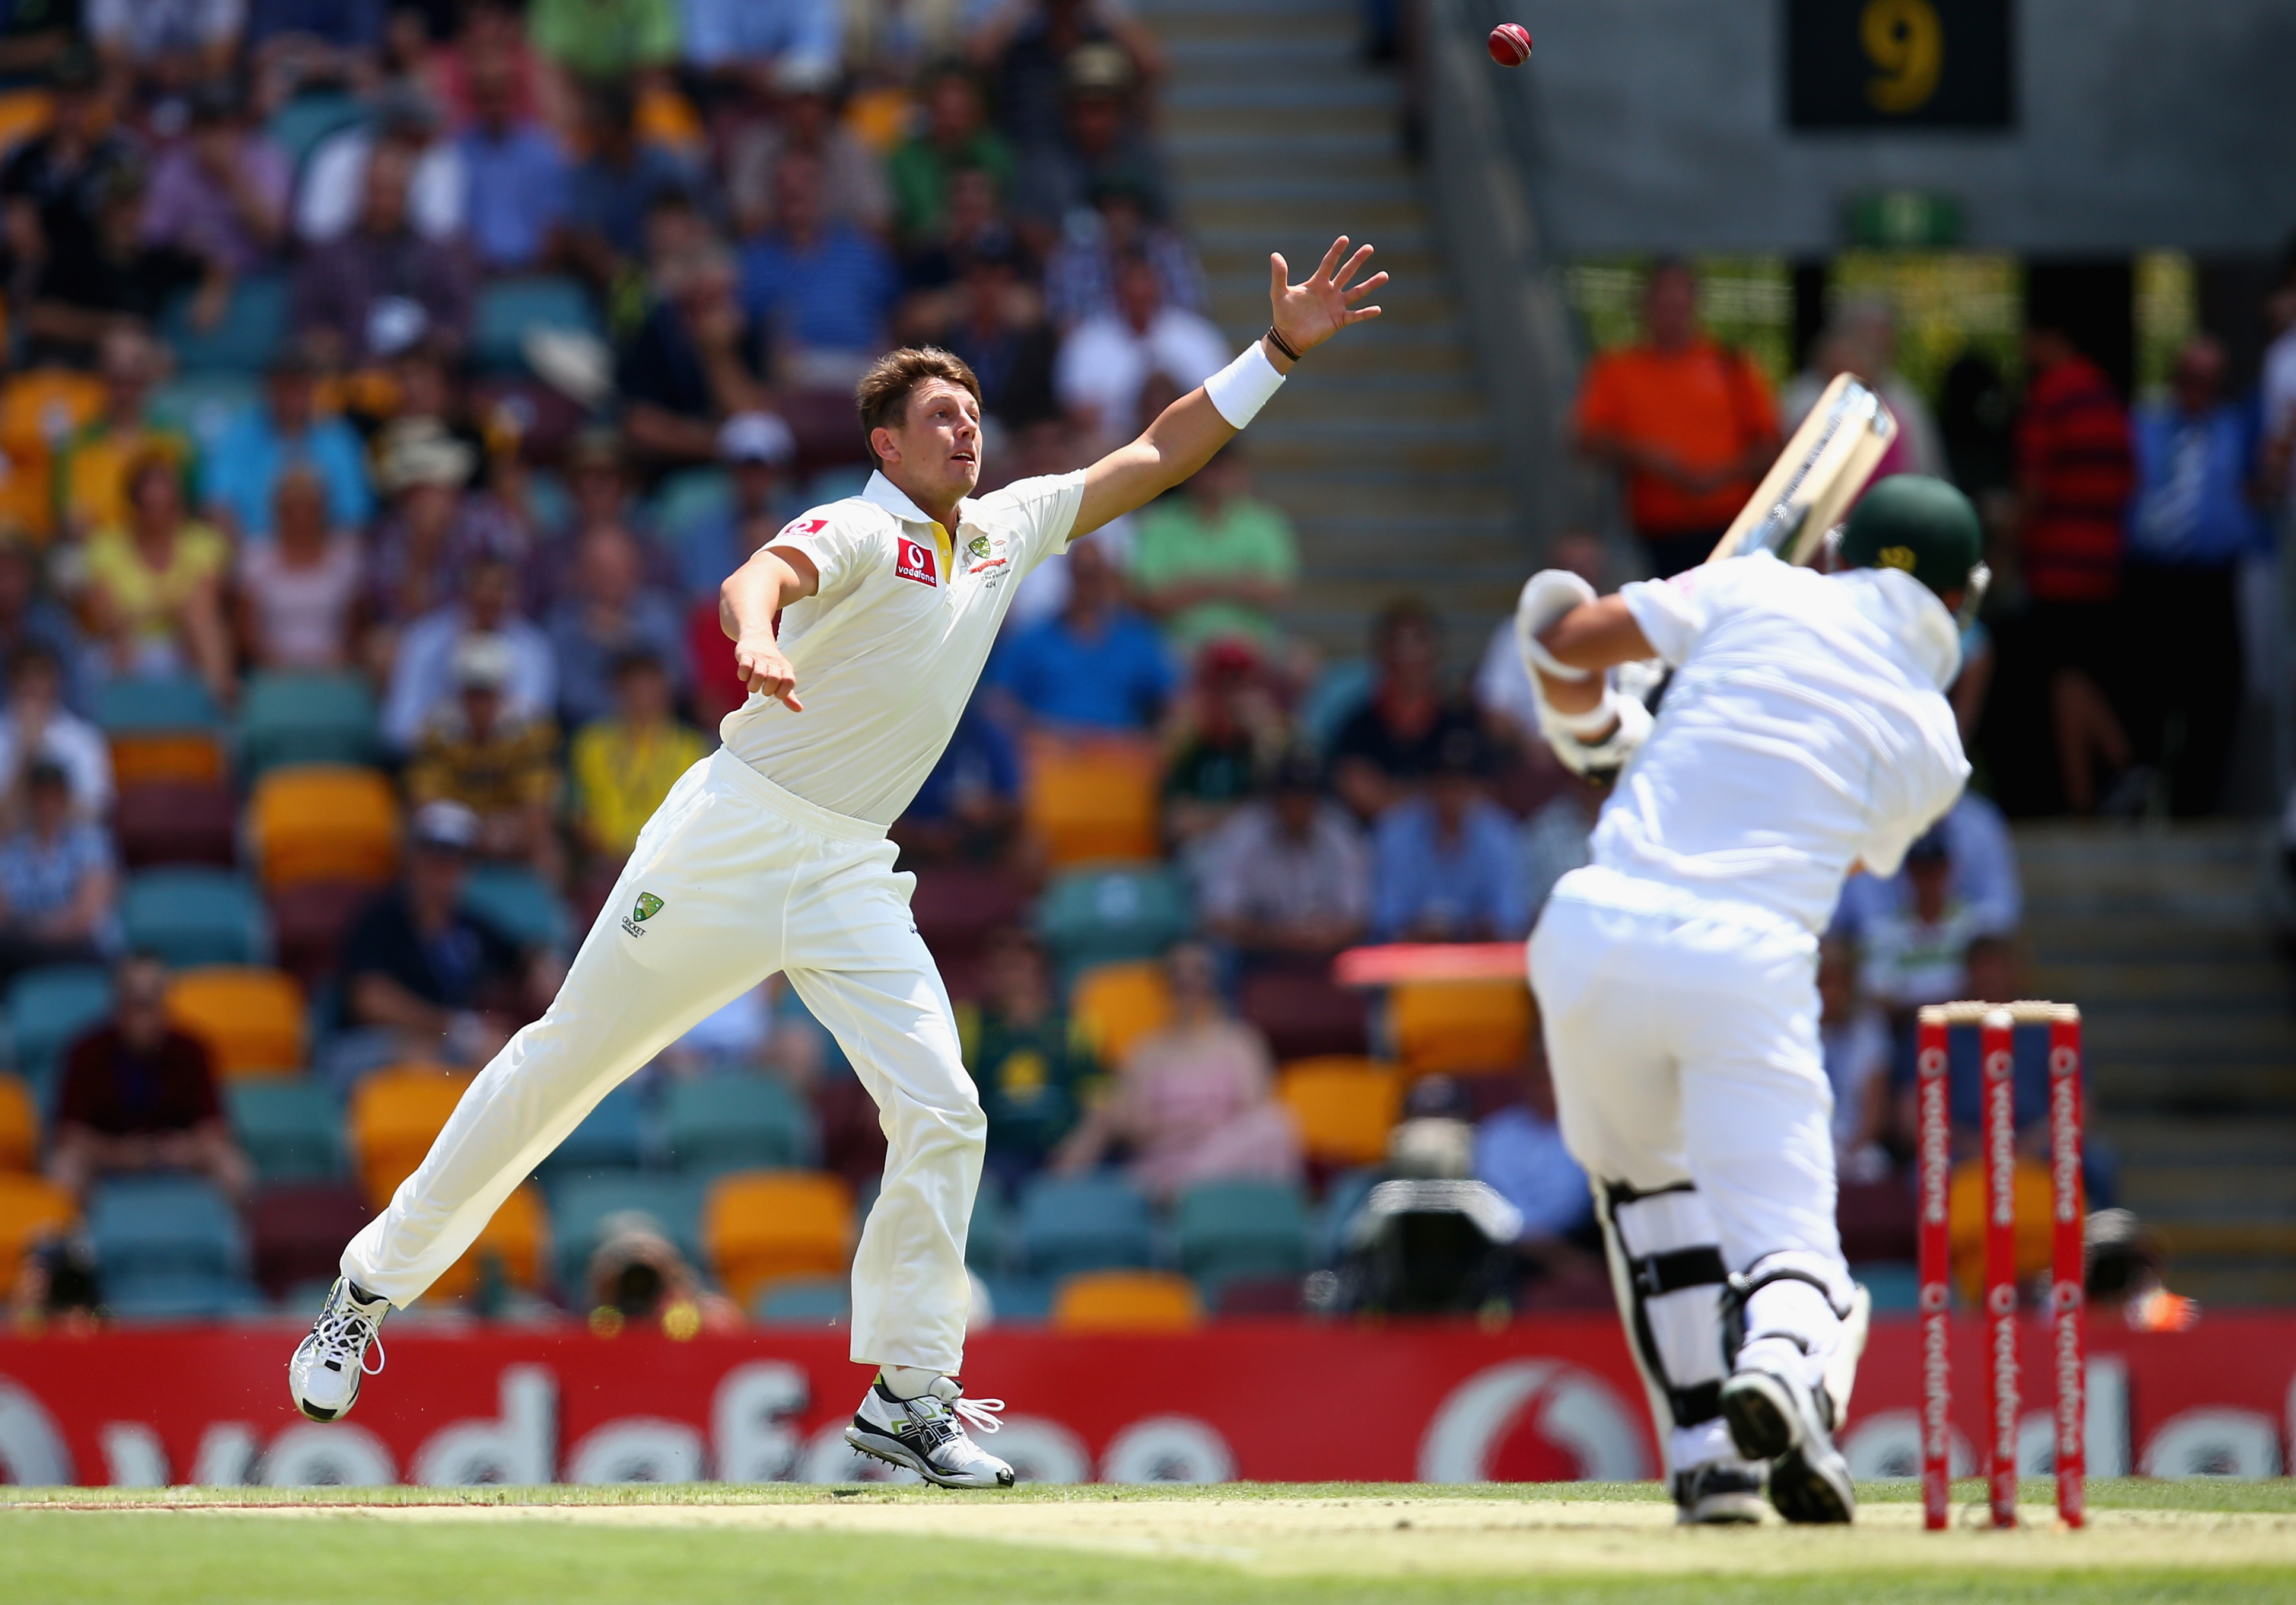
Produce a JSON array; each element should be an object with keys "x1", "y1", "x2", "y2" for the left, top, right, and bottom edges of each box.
[{"x1": 0, "y1": 1481, "x2": 2296, "y2": 1605}]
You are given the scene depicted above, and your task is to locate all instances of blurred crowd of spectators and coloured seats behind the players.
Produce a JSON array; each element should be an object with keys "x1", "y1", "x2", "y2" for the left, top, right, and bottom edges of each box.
[{"x1": 0, "y1": 0, "x2": 2268, "y2": 1323}]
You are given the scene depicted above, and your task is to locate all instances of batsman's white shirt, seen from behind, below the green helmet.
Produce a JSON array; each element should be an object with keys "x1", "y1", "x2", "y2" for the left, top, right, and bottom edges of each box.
[{"x1": 1591, "y1": 553, "x2": 1970, "y2": 932}]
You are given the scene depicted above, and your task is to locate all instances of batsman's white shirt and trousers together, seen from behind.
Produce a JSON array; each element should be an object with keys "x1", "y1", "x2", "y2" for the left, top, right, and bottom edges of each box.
[{"x1": 1531, "y1": 556, "x2": 1968, "y2": 1396}]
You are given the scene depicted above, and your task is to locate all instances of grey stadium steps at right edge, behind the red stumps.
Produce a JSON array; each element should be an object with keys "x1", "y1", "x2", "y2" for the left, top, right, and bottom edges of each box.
[{"x1": 2016, "y1": 822, "x2": 2296, "y2": 1307}]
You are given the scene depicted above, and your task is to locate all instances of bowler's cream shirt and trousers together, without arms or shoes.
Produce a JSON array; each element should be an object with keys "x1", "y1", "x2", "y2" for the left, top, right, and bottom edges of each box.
[{"x1": 342, "y1": 473, "x2": 1084, "y2": 1373}]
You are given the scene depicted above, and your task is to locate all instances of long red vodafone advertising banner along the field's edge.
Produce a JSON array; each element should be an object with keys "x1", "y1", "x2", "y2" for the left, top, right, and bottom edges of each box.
[{"x1": 0, "y1": 1313, "x2": 2296, "y2": 1486}]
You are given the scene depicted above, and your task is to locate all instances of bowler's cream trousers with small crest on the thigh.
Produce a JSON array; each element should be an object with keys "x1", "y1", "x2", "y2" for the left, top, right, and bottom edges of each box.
[{"x1": 342, "y1": 751, "x2": 987, "y2": 1373}]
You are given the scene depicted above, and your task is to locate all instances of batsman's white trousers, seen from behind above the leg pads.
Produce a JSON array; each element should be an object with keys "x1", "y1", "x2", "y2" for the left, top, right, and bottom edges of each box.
[{"x1": 1531, "y1": 865, "x2": 1850, "y2": 1304}]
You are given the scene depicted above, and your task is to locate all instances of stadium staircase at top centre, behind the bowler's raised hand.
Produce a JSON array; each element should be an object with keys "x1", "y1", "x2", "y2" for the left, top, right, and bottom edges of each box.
[{"x1": 1139, "y1": 0, "x2": 1527, "y2": 661}]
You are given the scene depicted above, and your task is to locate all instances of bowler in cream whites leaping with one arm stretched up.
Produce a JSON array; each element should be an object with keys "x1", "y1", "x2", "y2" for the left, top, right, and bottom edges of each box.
[{"x1": 287, "y1": 237, "x2": 1386, "y2": 1488}]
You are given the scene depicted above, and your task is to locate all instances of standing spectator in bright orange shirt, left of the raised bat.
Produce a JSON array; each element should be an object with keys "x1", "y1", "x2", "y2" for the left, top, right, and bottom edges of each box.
[{"x1": 1573, "y1": 262, "x2": 1777, "y2": 579}]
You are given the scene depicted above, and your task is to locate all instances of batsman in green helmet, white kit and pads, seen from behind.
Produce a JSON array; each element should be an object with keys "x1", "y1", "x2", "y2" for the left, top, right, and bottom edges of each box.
[{"x1": 1515, "y1": 475, "x2": 1984, "y2": 1523}]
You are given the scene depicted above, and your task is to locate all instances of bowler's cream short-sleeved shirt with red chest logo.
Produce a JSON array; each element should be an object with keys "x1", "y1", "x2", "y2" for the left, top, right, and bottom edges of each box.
[{"x1": 718, "y1": 471, "x2": 1084, "y2": 824}]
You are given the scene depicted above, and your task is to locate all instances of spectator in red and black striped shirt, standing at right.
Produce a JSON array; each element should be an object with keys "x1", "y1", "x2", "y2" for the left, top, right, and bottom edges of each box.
[{"x1": 2016, "y1": 324, "x2": 2135, "y2": 813}]
